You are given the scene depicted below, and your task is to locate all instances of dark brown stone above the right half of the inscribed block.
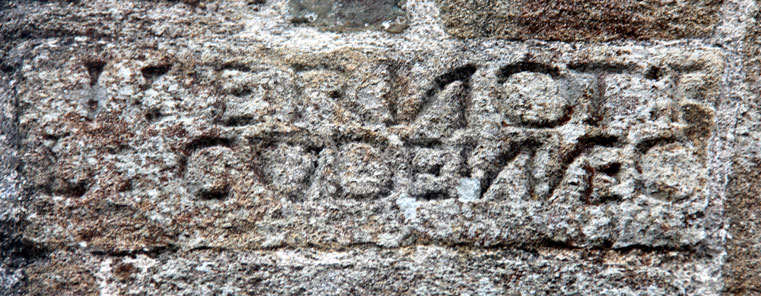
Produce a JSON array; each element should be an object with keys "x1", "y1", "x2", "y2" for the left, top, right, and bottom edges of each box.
[{"x1": 437, "y1": 0, "x2": 723, "y2": 41}]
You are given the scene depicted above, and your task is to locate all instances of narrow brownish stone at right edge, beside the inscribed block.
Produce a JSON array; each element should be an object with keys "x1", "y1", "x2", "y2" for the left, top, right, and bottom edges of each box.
[{"x1": 724, "y1": 6, "x2": 761, "y2": 295}]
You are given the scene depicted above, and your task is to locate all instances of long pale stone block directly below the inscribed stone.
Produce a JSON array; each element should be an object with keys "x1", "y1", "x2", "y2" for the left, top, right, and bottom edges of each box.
[{"x1": 25, "y1": 246, "x2": 702, "y2": 295}]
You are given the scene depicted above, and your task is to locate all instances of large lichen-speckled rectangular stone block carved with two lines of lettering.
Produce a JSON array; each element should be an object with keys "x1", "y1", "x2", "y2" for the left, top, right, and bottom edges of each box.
[{"x1": 10, "y1": 38, "x2": 722, "y2": 251}]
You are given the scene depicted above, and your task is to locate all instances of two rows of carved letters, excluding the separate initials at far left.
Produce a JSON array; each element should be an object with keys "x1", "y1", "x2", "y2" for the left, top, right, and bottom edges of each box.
[{"x1": 192, "y1": 56, "x2": 713, "y2": 205}]
